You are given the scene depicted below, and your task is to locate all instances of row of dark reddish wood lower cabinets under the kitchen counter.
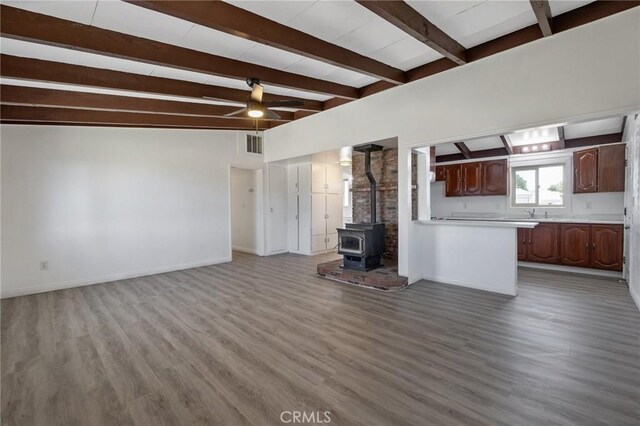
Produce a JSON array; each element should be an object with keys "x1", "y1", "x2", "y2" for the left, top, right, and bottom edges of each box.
[{"x1": 517, "y1": 223, "x2": 623, "y2": 271}]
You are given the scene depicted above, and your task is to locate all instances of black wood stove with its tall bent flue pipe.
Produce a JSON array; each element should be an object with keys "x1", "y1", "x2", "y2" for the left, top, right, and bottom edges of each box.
[{"x1": 338, "y1": 144, "x2": 384, "y2": 271}]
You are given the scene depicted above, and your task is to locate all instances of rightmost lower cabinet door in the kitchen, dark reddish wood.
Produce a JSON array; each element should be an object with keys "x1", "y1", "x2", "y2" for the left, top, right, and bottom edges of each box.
[{"x1": 591, "y1": 225, "x2": 623, "y2": 271}]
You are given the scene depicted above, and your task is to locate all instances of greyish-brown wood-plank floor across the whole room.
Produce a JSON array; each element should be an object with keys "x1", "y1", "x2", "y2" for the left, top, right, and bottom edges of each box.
[{"x1": 1, "y1": 253, "x2": 640, "y2": 426}]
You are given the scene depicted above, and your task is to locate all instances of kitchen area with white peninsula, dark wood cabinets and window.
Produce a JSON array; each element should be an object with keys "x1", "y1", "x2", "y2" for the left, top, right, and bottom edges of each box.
[{"x1": 414, "y1": 117, "x2": 632, "y2": 295}]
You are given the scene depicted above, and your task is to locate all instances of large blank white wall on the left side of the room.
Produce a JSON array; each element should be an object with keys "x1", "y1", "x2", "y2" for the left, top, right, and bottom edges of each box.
[{"x1": 0, "y1": 125, "x2": 262, "y2": 297}]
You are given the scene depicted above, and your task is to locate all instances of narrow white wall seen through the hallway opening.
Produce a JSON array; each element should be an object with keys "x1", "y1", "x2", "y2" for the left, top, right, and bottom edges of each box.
[{"x1": 231, "y1": 167, "x2": 262, "y2": 254}]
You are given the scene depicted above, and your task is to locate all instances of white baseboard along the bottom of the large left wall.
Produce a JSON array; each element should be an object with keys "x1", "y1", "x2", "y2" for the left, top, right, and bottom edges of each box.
[{"x1": 0, "y1": 257, "x2": 231, "y2": 299}]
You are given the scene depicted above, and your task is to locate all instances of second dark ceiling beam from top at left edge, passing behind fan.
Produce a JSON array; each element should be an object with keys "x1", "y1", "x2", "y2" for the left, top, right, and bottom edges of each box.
[{"x1": 0, "y1": 55, "x2": 322, "y2": 111}]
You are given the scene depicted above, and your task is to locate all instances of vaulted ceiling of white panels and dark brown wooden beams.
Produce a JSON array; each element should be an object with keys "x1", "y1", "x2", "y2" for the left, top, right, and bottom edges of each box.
[{"x1": 0, "y1": 0, "x2": 640, "y2": 129}]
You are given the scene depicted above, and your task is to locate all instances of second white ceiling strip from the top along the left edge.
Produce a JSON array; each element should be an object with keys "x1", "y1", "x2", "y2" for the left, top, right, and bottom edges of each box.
[{"x1": 0, "y1": 38, "x2": 331, "y2": 101}]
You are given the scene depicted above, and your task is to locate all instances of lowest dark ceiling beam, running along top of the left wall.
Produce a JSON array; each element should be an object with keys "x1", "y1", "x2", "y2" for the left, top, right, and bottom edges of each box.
[{"x1": 0, "y1": 105, "x2": 268, "y2": 130}]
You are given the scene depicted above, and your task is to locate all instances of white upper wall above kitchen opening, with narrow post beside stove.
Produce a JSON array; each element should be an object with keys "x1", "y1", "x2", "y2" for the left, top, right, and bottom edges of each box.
[{"x1": 265, "y1": 8, "x2": 640, "y2": 275}]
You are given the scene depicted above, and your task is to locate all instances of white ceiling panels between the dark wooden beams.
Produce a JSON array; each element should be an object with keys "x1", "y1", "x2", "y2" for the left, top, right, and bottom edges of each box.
[{"x1": 0, "y1": 0, "x2": 600, "y2": 110}]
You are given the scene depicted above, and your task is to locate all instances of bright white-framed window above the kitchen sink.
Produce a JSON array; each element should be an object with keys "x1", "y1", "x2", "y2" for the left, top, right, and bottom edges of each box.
[{"x1": 511, "y1": 164, "x2": 566, "y2": 207}]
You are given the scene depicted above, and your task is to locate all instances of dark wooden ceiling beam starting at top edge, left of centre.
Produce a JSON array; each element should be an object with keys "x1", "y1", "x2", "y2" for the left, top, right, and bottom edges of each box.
[{"x1": 125, "y1": 0, "x2": 405, "y2": 85}]
